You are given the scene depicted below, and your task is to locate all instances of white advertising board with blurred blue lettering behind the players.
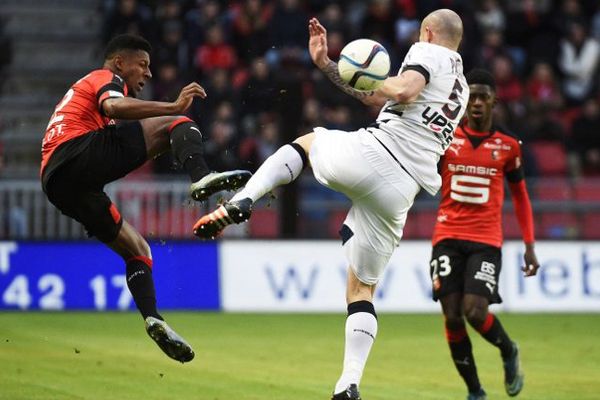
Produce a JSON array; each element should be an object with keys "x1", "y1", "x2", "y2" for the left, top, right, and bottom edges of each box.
[{"x1": 219, "y1": 241, "x2": 600, "y2": 312}]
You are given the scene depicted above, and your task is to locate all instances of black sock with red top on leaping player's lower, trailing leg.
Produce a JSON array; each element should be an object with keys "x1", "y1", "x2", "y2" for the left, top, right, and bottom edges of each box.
[{"x1": 126, "y1": 257, "x2": 163, "y2": 320}]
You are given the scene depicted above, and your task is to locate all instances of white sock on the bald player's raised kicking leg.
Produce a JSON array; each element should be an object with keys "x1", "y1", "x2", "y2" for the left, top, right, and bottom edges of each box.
[{"x1": 231, "y1": 144, "x2": 304, "y2": 203}]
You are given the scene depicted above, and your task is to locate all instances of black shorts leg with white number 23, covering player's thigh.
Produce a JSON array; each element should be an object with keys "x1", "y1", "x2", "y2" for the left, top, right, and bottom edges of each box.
[{"x1": 429, "y1": 239, "x2": 466, "y2": 301}]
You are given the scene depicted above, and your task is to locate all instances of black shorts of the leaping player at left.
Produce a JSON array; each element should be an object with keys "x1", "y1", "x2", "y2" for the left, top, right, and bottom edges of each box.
[{"x1": 42, "y1": 121, "x2": 146, "y2": 243}]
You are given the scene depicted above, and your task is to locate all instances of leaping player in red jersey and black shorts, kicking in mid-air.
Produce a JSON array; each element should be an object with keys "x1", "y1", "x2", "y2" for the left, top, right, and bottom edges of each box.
[{"x1": 40, "y1": 35, "x2": 250, "y2": 362}]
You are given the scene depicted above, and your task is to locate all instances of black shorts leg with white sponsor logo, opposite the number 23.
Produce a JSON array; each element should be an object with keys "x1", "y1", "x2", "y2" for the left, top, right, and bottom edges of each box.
[{"x1": 465, "y1": 242, "x2": 502, "y2": 303}]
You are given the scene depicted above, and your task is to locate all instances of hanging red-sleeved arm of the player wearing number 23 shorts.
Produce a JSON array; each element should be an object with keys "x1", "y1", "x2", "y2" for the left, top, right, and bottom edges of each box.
[{"x1": 506, "y1": 157, "x2": 540, "y2": 276}]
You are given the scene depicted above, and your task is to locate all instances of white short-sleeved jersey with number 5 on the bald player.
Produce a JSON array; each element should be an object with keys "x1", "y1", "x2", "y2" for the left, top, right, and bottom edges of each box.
[{"x1": 369, "y1": 42, "x2": 469, "y2": 195}]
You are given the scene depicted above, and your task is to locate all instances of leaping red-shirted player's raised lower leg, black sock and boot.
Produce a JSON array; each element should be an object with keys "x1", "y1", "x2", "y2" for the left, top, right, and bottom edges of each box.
[{"x1": 169, "y1": 117, "x2": 252, "y2": 201}]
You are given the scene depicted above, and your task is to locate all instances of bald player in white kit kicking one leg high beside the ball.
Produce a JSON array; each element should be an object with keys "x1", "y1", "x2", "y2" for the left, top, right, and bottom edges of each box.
[{"x1": 194, "y1": 9, "x2": 469, "y2": 400}]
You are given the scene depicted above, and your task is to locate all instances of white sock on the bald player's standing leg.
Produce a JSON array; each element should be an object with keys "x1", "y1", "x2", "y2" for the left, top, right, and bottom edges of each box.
[{"x1": 333, "y1": 312, "x2": 377, "y2": 393}]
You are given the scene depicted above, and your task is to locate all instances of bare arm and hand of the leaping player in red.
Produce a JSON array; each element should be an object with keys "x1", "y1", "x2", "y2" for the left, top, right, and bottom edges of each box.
[{"x1": 100, "y1": 82, "x2": 206, "y2": 119}]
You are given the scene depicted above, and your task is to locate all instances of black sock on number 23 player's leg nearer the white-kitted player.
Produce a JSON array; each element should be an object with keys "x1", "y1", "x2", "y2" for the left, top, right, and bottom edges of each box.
[{"x1": 446, "y1": 325, "x2": 481, "y2": 393}]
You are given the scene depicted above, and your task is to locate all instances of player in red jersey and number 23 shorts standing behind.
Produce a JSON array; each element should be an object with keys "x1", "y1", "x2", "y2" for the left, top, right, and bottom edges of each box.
[{"x1": 430, "y1": 69, "x2": 539, "y2": 400}]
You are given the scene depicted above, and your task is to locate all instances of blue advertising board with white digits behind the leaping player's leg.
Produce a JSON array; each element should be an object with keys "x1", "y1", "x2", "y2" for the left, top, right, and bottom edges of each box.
[{"x1": 0, "y1": 241, "x2": 220, "y2": 310}]
